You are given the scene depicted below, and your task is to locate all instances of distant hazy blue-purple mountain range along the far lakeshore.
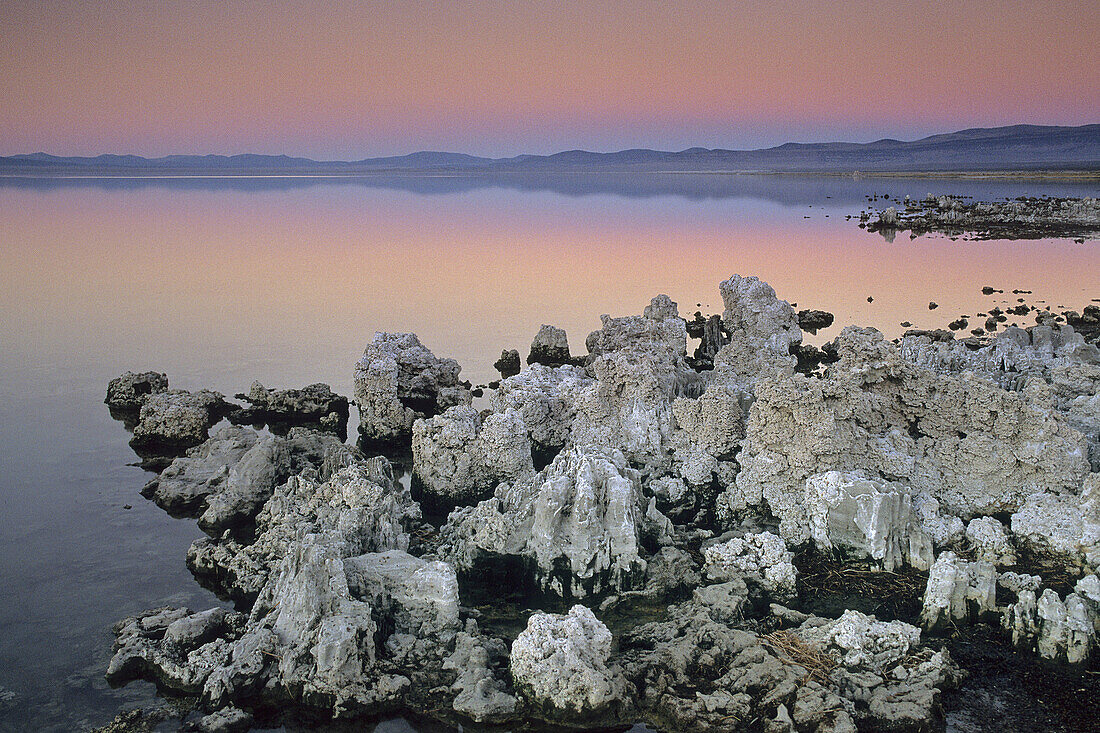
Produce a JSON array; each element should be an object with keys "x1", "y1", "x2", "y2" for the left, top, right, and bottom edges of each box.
[{"x1": 0, "y1": 124, "x2": 1100, "y2": 175}]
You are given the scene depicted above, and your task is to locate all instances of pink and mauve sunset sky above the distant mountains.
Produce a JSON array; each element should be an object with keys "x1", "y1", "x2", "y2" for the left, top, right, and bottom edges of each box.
[{"x1": 0, "y1": 0, "x2": 1100, "y2": 160}]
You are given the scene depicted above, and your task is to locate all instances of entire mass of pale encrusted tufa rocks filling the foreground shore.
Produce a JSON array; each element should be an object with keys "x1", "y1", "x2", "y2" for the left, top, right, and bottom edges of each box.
[{"x1": 99, "y1": 270, "x2": 1100, "y2": 733}]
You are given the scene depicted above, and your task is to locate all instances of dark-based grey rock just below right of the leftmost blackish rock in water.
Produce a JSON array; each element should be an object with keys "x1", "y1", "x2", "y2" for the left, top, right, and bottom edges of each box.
[{"x1": 130, "y1": 390, "x2": 229, "y2": 459}]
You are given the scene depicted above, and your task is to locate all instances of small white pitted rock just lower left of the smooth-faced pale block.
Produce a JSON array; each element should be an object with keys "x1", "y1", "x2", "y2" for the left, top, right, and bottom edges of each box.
[{"x1": 703, "y1": 532, "x2": 798, "y2": 601}]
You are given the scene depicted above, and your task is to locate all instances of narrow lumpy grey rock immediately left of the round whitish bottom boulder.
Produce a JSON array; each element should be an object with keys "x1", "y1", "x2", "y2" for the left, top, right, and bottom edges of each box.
[{"x1": 443, "y1": 619, "x2": 518, "y2": 723}]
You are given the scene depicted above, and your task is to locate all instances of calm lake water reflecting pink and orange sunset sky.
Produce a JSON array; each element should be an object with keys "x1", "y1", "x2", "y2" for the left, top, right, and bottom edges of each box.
[{"x1": 0, "y1": 174, "x2": 1100, "y2": 731}]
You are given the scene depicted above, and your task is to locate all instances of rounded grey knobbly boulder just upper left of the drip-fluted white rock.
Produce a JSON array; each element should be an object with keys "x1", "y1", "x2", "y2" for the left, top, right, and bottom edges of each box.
[{"x1": 413, "y1": 405, "x2": 535, "y2": 507}]
